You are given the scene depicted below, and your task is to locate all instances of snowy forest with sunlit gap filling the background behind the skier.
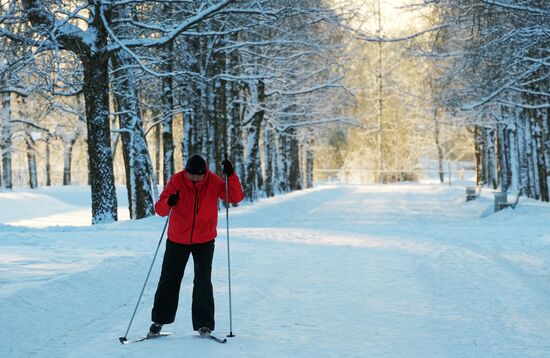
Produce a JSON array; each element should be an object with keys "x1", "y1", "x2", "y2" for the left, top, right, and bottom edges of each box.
[{"x1": 0, "y1": 0, "x2": 550, "y2": 224}]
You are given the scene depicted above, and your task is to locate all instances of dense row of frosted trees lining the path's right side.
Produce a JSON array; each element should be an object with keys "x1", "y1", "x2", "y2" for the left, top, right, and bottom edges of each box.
[{"x1": 433, "y1": 0, "x2": 550, "y2": 201}]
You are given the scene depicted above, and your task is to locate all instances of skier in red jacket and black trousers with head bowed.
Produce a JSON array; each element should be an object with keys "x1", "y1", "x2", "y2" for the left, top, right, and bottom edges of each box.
[{"x1": 151, "y1": 155, "x2": 244, "y2": 337}]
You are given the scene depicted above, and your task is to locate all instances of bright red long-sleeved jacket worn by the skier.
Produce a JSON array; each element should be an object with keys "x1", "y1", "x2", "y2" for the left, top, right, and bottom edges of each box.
[{"x1": 155, "y1": 170, "x2": 244, "y2": 245}]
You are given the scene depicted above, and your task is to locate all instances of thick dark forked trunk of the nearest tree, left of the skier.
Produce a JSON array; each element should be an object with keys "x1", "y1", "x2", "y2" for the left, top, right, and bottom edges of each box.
[{"x1": 22, "y1": 0, "x2": 121, "y2": 224}]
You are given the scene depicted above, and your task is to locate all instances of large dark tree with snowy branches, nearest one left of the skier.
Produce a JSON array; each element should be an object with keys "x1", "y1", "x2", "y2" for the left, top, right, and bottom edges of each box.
[{"x1": 7, "y1": 0, "x2": 239, "y2": 224}]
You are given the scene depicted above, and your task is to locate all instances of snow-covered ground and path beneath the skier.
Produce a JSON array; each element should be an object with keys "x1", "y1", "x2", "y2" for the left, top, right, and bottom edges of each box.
[{"x1": 0, "y1": 184, "x2": 550, "y2": 357}]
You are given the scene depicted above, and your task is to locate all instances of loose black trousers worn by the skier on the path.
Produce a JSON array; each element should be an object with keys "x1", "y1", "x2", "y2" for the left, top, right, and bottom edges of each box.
[{"x1": 151, "y1": 240, "x2": 219, "y2": 331}]
